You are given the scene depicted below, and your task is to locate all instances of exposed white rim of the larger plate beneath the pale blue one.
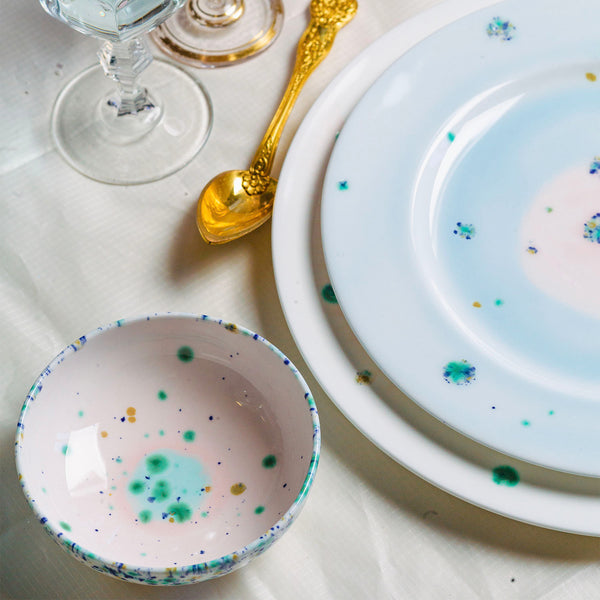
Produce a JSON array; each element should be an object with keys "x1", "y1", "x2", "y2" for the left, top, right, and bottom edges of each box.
[{"x1": 272, "y1": 0, "x2": 600, "y2": 536}]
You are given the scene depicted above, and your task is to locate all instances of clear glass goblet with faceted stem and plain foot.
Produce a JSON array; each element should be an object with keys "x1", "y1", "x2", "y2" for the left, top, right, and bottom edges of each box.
[{"x1": 40, "y1": 0, "x2": 212, "y2": 185}]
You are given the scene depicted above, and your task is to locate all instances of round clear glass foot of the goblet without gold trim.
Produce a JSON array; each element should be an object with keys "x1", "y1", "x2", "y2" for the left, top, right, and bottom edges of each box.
[{"x1": 52, "y1": 60, "x2": 212, "y2": 185}]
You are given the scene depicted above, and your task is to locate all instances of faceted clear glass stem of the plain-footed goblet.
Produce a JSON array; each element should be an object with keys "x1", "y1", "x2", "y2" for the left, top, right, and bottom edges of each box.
[{"x1": 98, "y1": 38, "x2": 155, "y2": 117}]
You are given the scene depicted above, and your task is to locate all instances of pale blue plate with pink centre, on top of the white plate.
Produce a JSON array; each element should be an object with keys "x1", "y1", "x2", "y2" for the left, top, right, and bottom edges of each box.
[{"x1": 322, "y1": 0, "x2": 600, "y2": 477}]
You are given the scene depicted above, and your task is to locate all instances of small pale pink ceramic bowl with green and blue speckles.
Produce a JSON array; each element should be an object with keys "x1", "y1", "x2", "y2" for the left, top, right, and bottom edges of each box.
[{"x1": 16, "y1": 314, "x2": 320, "y2": 585}]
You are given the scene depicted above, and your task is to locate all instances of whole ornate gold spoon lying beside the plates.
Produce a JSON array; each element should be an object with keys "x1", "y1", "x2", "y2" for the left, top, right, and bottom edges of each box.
[{"x1": 196, "y1": 0, "x2": 358, "y2": 244}]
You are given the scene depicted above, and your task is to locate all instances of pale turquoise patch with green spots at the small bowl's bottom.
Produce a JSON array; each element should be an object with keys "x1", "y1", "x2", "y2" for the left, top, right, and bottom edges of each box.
[{"x1": 127, "y1": 449, "x2": 210, "y2": 523}]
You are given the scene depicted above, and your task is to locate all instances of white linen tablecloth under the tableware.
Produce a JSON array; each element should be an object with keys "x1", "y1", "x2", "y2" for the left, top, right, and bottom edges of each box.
[{"x1": 0, "y1": 0, "x2": 600, "y2": 600}]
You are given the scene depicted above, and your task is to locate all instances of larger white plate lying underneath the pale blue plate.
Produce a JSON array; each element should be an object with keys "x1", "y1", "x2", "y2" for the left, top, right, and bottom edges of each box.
[{"x1": 272, "y1": 0, "x2": 600, "y2": 536}]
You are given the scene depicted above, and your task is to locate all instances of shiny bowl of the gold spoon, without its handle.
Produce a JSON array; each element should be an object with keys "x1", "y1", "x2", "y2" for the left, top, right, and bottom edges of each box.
[{"x1": 197, "y1": 171, "x2": 277, "y2": 244}]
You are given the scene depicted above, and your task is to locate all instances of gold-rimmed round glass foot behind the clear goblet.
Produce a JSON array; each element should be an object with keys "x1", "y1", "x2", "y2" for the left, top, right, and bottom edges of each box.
[{"x1": 150, "y1": 0, "x2": 283, "y2": 67}]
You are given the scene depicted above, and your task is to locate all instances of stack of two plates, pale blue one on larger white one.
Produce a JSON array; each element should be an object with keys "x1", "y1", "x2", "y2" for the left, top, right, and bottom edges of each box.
[{"x1": 273, "y1": 0, "x2": 600, "y2": 535}]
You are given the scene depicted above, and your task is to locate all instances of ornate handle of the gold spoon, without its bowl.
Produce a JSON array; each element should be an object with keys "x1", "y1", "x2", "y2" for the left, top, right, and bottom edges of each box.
[{"x1": 243, "y1": 0, "x2": 358, "y2": 194}]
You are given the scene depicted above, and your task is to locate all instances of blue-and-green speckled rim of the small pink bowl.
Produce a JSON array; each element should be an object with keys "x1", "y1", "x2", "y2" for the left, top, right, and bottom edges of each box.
[{"x1": 15, "y1": 311, "x2": 321, "y2": 583}]
